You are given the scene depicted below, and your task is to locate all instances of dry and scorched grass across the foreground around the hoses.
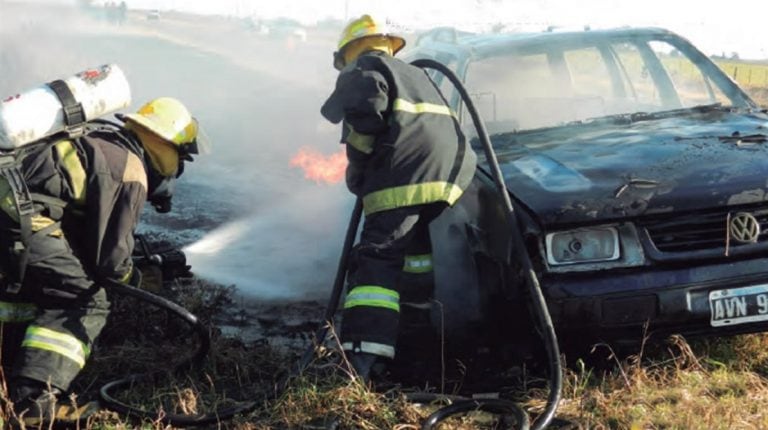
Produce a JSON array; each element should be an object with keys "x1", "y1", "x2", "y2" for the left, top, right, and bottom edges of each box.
[{"x1": 7, "y1": 276, "x2": 768, "y2": 430}]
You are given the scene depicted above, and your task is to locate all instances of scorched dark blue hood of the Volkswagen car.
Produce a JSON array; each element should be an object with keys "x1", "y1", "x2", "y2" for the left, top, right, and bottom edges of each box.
[{"x1": 492, "y1": 111, "x2": 768, "y2": 225}]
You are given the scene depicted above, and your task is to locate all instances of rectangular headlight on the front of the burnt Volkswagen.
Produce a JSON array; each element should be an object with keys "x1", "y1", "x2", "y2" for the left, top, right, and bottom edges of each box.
[{"x1": 546, "y1": 227, "x2": 620, "y2": 266}]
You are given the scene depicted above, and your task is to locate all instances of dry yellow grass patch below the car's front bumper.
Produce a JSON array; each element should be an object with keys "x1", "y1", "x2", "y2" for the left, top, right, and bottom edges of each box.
[{"x1": 559, "y1": 335, "x2": 768, "y2": 429}]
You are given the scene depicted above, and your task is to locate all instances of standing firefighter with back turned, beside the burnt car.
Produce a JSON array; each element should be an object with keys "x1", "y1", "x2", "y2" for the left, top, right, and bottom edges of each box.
[{"x1": 321, "y1": 15, "x2": 477, "y2": 380}]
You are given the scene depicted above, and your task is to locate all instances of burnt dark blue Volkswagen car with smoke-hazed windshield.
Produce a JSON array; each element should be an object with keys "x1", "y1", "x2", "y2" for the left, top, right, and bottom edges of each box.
[{"x1": 404, "y1": 28, "x2": 768, "y2": 356}]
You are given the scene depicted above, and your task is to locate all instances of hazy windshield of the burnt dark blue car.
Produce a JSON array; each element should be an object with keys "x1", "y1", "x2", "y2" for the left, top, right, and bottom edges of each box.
[{"x1": 463, "y1": 34, "x2": 736, "y2": 134}]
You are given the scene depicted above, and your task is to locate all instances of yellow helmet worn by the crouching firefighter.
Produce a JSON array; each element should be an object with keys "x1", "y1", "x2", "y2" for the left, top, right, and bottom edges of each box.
[{"x1": 125, "y1": 97, "x2": 209, "y2": 159}]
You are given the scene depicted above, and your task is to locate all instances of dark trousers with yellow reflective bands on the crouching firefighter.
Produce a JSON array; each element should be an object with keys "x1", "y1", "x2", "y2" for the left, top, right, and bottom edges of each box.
[{"x1": 0, "y1": 235, "x2": 109, "y2": 391}]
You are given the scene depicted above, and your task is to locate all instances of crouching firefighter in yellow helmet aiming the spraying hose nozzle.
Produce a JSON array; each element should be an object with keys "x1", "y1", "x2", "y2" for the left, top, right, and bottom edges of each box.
[{"x1": 0, "y1": 97, "x2": 203, "y2": 425}]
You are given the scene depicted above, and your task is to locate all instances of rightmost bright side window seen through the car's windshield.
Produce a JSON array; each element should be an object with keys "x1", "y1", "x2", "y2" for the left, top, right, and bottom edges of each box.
[{"x1": 648, "y1": 41, "x2": 730, "y2": 107}]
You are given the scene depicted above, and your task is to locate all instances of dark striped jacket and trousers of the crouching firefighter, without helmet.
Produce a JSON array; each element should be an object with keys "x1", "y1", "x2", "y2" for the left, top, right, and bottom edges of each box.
[{"x1": 0, "y1": 129, "x2": 147, "y2": 391}]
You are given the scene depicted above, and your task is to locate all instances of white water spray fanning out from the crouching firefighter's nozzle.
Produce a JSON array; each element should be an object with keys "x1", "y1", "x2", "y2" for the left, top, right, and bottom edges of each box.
[{"x1": 184, "y1": 187, "x2": 352, "y2": 300}]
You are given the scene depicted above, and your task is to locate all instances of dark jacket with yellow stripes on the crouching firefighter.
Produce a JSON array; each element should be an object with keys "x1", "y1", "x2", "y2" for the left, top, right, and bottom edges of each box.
[{"x1": 0, "y1": 130, "x2": 147, "y2": 282}]
